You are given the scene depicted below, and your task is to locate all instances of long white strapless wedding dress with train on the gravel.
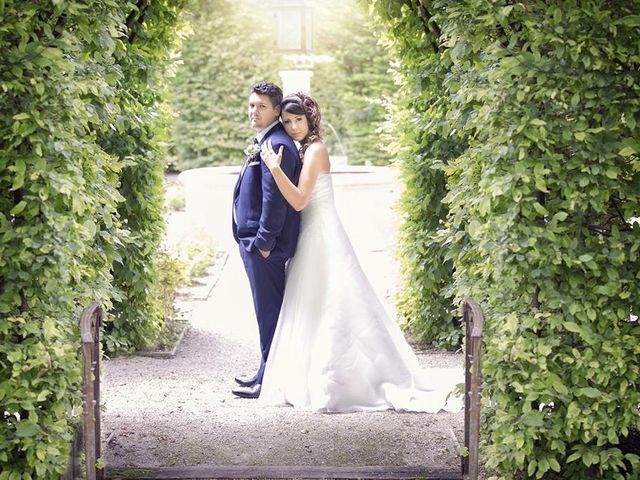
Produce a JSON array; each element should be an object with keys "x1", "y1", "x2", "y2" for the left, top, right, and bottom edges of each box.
[{"x1": 260, "y1": 174, "x2": 463, "y2": 413}]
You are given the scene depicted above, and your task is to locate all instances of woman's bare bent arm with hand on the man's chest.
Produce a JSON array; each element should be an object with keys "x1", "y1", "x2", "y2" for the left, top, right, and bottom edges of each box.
[{"x1": 262, "y1": 142, "x2": 329, "y2": 212}]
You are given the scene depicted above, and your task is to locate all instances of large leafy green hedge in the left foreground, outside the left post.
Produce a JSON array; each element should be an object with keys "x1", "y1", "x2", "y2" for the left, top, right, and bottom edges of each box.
[{"x1": 0, "y1": 0, "x2": 185, "y2": 474}]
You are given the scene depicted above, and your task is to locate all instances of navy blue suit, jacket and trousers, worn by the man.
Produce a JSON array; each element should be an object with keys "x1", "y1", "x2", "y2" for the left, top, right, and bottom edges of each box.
[{"x1": 232, "y1": 122, "x2": 302, "y2": 383}]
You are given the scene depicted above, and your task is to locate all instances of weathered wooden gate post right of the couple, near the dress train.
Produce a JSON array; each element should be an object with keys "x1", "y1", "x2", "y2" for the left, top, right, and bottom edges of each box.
[{"x1": 462, "y1": 299, "x2": 484, "y2": 480}]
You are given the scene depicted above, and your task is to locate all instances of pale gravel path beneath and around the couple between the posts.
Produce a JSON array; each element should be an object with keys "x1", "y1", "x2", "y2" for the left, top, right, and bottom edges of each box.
[{"x1": 102, "y1": 169, "x2": 463, "y2": 468}]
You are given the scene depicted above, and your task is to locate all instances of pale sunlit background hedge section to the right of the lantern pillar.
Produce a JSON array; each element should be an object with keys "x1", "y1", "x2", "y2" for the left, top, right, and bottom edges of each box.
[{"x1": 311, "y1": 0, "x2": 394, "y2": 165}]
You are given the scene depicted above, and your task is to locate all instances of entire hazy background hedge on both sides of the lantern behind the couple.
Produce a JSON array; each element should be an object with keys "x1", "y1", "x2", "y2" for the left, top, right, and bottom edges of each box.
[{"x1": 170, "y1": 0, "x2": 393, "y2": 170}]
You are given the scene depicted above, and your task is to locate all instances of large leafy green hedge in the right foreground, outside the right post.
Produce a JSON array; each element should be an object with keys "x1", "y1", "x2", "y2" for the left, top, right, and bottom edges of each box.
[{"x1": 371, "y1": 0, "x2": 640, "y2": 479}]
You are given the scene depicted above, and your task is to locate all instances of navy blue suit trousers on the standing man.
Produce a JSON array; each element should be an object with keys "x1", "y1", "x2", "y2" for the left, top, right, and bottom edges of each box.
[{"x1": 240, "y1": 245, "x2": 287, "y2": 383}]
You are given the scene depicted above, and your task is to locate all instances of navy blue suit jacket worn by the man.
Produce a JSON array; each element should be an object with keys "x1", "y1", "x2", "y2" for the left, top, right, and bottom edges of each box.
[{"x1": 232, "y1": 122, "x2": 302, "y2": 258}]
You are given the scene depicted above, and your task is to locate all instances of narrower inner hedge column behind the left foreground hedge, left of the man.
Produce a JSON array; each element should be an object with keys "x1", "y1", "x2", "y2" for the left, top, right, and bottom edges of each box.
[{"x1": 99, "y1": 0, "x2": 186, "y2": 351}]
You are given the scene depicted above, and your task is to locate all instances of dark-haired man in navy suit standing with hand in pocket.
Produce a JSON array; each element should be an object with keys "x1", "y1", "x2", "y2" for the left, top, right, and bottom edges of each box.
[{"x1": 233, "y1": 82, "x2": 302, "y2": 398}]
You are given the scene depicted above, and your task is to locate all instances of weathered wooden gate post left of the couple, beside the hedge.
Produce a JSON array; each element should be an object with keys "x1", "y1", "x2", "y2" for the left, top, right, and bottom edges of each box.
[{"x1": 80, "y1": 302, "x2": 104, "y2": 480}]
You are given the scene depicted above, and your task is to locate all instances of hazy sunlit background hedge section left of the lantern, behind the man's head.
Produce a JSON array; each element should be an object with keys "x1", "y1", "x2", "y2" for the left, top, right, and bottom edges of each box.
[{"x1": 170, "y1": 0, "x2": 282, "y2": 171}]
